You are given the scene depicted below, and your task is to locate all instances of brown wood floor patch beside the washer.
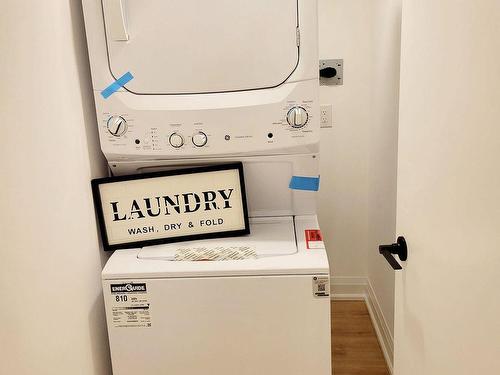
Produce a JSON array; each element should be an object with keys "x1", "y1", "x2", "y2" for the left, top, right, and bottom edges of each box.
[{"x1": 332, "y1": 301, "x2": 389, "y2": 375}]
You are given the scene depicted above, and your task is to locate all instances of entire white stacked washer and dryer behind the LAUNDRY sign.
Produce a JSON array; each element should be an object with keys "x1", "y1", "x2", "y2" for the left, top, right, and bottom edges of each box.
[{"x1": 83, "y1": 0, "x2": 331, "y2": 375}]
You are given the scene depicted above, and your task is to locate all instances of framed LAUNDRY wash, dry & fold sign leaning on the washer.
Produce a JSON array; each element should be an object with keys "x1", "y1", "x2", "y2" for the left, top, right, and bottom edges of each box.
[{"x1": 92, "y1": 163, "x2": 250, "y2": 250}]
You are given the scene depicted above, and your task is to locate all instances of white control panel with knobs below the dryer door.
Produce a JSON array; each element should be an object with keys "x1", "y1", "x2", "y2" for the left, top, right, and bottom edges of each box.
[{"x1": 95, "y1": 81, "x2": 319, "y2": 160}]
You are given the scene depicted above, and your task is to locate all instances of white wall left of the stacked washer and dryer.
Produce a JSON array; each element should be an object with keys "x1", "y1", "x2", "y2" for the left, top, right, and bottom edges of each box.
[{"x1": 0, "y1": 0, "x2": 110, "y2": 375}]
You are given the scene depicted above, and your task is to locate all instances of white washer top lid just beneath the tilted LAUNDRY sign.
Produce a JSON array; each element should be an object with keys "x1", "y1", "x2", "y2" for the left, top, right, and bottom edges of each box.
[{"x1": 137, "y1": 217, "x2": 297, "y2": 261}]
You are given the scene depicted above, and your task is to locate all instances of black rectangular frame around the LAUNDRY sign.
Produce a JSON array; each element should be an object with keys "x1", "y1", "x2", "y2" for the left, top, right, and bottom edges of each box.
[{"x1": 91, "y1": 162, "x2": 250, "y2": 251}]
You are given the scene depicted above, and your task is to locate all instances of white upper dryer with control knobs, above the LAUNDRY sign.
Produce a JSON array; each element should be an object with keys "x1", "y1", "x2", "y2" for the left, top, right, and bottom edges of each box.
[{"x1": 82, "y1": 0, "x2": 319, "y2": 166}]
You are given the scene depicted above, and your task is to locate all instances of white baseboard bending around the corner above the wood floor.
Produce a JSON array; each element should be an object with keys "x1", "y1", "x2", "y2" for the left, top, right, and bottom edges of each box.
[{"x1": 330, "y1": 276, "x2": 394, "y2": 374}]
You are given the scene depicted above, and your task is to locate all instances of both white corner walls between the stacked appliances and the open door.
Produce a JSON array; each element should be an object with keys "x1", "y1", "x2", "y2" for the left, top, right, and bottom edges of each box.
[{"x1": 319, "y1": 0, "x2": 401, "y2": 340}]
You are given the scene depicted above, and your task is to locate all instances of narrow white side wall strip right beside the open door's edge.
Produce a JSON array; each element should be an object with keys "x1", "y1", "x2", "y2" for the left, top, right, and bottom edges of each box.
[{"x1": 367, "y1": 0, "x2": 401, "y2": 336}]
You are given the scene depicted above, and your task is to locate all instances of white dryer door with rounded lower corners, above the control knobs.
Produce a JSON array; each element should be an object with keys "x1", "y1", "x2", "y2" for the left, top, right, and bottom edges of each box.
[{"x1": 102, "y1": 0, "x2": 299, "y2": 94}]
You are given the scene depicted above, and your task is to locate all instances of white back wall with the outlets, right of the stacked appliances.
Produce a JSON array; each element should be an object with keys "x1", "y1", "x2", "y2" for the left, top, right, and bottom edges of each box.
[{"x1": 319, "y1": 0, "x2": 373, "y2": 277}]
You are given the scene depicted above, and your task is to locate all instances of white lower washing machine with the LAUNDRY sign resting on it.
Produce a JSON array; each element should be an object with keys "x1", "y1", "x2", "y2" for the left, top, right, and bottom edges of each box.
[{"x1": 103, "y1": 216, "x2": 331, "y2": 375}]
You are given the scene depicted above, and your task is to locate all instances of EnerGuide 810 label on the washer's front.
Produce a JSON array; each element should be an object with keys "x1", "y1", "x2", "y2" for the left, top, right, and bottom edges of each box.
[{"x1": 110, "y1": 282, "x2": 151, "y2": 328}]
